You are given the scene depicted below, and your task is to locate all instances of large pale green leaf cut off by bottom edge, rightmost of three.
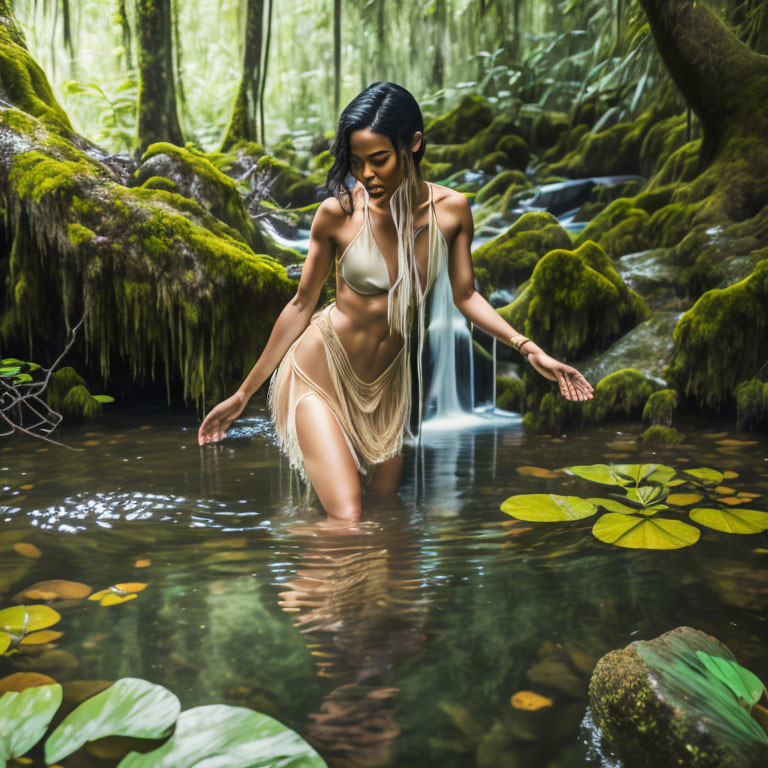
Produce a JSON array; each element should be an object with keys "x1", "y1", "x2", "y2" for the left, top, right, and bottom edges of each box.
[{"x1": 118, "y1": 704, "x2": 327, "y2": 768}]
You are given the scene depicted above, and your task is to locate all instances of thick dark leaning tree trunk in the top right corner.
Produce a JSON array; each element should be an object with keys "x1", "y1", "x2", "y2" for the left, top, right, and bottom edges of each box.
[{"x1": 640, "y1": 0, "x2": 768, "y2": 162}]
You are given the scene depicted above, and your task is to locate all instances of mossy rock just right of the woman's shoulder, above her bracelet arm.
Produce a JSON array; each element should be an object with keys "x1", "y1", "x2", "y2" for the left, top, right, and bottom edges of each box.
[{"x1": 472, "y1": 212, "x2": 571, "y2": 288}]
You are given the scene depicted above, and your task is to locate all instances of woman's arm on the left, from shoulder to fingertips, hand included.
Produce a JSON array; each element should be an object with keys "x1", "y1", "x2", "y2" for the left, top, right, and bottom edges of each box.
[{"x1": 198, "y1": 197, "x2": 345, "y2": 445}]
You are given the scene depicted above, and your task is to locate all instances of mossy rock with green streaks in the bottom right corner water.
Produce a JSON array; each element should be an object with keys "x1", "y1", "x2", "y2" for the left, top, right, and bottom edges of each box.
[{"x1": 589, "y1": 627, "x2": 768, "y2": 768}]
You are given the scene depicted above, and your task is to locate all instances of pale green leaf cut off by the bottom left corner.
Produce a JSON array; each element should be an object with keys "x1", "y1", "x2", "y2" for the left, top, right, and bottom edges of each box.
[{"x1": 0, "y1": 683, "x2": 61, "y2": 766}]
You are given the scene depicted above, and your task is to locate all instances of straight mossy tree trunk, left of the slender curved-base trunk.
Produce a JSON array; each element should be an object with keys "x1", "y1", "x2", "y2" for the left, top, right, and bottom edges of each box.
[{"x1": 136, "y1": 0, "x2": 184, "y2": 154}]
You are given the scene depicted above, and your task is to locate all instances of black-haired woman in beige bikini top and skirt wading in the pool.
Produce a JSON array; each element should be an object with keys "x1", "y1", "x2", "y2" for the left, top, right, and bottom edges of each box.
[{"x1": 198, "y1": 82, "x2": 592, "y2": 522}]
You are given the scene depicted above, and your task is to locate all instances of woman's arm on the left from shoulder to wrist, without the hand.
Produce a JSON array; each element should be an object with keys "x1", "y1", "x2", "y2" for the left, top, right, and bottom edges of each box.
[{"x1": 238, "y1": 197, "x2": 343, "y2": 402}]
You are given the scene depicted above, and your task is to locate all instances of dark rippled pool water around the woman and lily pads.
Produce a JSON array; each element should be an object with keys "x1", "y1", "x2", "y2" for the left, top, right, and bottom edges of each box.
[{"x1": 0, "y1": 404, "x2": 768, "y2": 768}]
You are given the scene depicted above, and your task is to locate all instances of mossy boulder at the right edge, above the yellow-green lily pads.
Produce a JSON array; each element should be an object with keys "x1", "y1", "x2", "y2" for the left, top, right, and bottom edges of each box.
[{"x1": 666, "y1": 259, "x2": 768, "y2": 409}]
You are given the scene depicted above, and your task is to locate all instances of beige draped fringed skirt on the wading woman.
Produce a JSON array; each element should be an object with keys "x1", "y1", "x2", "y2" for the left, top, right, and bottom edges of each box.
[{"x1": 267, "y1": 303, "x2": 411, "y2": 502}]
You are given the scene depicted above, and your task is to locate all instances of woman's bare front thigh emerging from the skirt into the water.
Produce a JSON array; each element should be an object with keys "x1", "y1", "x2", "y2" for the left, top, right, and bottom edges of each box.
[{"x1": 296, "y1": 393, "x2": 362, "y2": 521}]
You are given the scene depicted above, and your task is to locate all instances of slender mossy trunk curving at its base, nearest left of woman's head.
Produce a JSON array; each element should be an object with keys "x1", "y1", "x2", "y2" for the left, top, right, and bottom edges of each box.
[{"x1": 221, "y1": 0, "x2": 264, "y2": 152}]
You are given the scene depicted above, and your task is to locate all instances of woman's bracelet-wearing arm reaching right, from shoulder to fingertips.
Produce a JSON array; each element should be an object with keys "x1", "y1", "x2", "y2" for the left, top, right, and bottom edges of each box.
[{"x1": 443, "y1": 193, "x2": 592, "y2": 400}]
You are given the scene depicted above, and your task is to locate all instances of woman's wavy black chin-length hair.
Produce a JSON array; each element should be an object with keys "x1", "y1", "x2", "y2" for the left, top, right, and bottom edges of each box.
[{"x1": 325, "y1": 81, "x2": 426, "y2": 212}]
